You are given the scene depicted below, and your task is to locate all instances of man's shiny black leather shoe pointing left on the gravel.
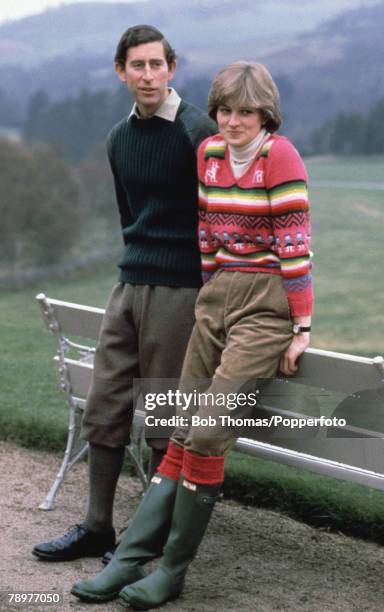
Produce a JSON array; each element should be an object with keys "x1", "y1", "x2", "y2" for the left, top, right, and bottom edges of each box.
[{"x1": 32, "y1": 525, "x2": 116, "y2": 561}]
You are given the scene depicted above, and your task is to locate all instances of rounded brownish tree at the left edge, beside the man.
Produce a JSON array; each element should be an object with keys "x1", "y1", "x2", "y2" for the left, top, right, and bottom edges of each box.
[{"x1": 0, "y1": 140, "x2": 81, "y2": 267}]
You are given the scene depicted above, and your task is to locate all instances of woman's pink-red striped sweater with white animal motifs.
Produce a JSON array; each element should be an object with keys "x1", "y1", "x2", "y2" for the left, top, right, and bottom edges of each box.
[{"x1": 198, "y1": 135, "x2": 313, "y2": 316}]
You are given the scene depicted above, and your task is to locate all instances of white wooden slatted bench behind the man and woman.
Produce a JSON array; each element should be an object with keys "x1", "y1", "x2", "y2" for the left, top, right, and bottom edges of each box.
[{"x1": 36, "y1": 293, "x2": 384, "y2": 510}]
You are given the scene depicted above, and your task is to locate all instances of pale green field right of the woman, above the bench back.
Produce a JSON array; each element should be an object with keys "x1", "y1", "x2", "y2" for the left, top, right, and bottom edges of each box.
[{"x1": 307, "y1": 157, "x2": 384, "y2": 356}]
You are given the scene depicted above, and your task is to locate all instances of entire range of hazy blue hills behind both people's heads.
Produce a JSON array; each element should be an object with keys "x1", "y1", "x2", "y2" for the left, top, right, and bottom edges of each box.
[{"x1": 0, "y1": 0, "x2": 384, "y2": 140}]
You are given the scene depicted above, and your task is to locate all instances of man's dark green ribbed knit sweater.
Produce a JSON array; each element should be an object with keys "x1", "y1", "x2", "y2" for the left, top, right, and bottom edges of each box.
[{"x1": 107, "y1": 101, "x2": 217, "y2": 287}]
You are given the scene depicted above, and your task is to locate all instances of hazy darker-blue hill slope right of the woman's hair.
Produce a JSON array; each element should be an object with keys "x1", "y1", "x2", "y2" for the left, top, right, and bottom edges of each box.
[{"x1": 265, "y1": 3, "x2": 384, "y2": 132}]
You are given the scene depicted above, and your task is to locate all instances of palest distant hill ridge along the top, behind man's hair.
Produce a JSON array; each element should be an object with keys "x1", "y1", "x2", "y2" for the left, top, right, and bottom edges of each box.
[{"x1": 0, "y1": 0, "x2": 375, "y2": 66}]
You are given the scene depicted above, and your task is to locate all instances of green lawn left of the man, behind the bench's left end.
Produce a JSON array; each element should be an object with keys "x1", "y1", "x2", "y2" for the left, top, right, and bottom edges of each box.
[{"x1": 0, "y1": 265, "x2": 116, "y2": 449}]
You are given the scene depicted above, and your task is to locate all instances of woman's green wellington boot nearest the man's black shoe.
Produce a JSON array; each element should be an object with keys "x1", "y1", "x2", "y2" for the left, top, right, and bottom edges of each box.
[{"x1": 71, "y1": 474, "x2": 178, "y2": 603}]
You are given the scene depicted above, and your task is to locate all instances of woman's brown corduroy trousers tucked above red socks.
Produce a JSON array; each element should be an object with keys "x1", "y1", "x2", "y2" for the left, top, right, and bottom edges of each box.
[{"x1": 172, "y1": 270, "x2": 292, "y2": 456}]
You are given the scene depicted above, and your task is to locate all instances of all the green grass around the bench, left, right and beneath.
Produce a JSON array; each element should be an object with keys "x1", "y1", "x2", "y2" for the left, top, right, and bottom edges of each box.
[{"x1": 0, "y1": 157, "x2": 384, "y2": 537}]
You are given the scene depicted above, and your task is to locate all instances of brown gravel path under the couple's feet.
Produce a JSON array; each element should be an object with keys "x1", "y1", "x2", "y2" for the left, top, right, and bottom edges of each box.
[{"x1": 0, "y1": 443, "x2": 384, "y2": 612}]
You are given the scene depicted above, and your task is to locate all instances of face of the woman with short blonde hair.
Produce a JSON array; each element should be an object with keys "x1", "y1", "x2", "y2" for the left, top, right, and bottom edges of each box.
[{"x1": 216, "y1": 104, "x2": 263, "y2": 147}]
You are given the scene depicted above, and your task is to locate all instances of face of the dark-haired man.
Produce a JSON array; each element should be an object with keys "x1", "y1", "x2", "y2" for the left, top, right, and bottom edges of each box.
[{"x1": 115, "y1": 41, "x2": 176, "y2": 117}]
